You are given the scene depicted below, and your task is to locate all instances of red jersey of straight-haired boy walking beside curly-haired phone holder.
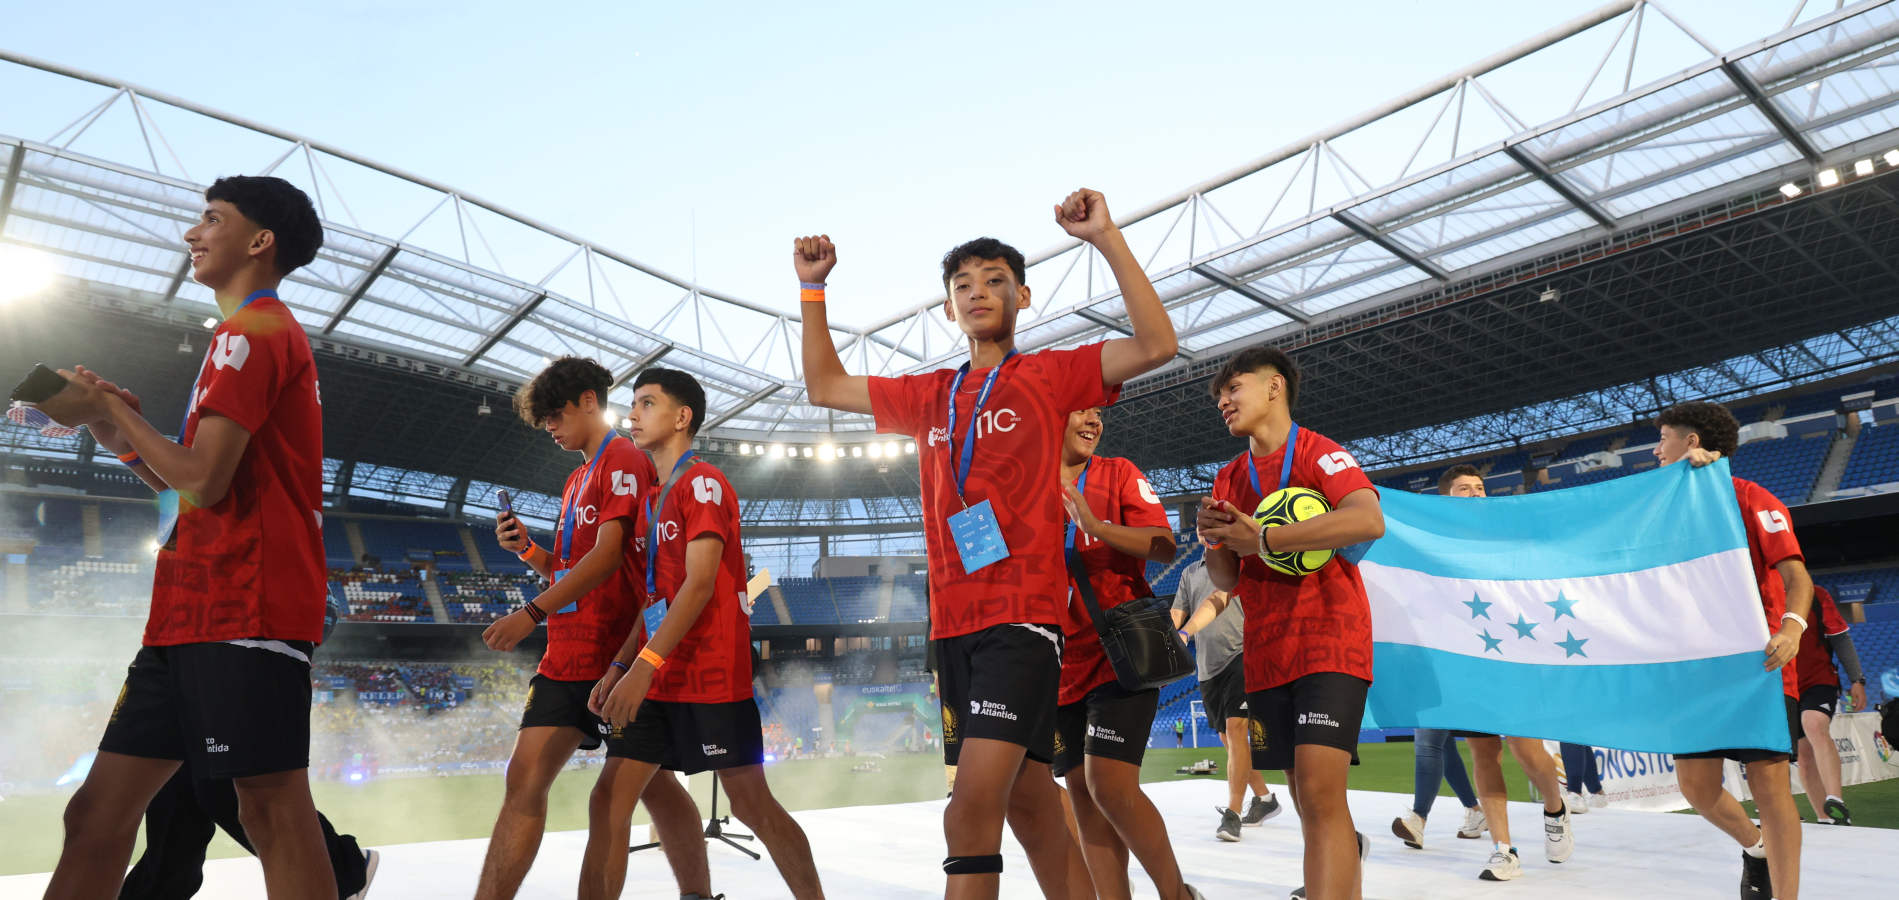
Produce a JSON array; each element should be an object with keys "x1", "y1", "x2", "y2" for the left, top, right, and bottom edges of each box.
[{"x1": 640, "y1": 458, "x2": 752, "y2": 703}]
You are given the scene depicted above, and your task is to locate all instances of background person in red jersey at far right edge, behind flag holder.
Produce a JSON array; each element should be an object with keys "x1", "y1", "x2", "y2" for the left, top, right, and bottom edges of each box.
[{"x1": 1793, "y1": 585, "x2": 1867, "y2": 826}]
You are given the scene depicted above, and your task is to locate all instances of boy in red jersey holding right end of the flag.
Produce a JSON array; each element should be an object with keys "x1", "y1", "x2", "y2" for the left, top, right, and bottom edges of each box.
[{"x1": 1654, "y1": 403, "x2": 1814, "y2": 900}]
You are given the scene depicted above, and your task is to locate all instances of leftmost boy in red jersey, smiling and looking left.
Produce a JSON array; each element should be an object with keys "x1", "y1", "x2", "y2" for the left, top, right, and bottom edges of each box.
[{"x1": 40, "y1": 177, "x2": 336, "y2": 900}]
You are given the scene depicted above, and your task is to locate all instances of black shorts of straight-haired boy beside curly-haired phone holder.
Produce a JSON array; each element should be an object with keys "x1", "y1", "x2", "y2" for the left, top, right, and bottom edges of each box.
[{"x1": 606, "y1": 699, "x2": 765, "y2": 775}]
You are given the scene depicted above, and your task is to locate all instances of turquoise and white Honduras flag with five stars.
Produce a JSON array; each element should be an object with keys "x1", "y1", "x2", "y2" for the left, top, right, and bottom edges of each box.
[{"x1": 1358, "y1": 459, "x2": 1789, "y2": 754}]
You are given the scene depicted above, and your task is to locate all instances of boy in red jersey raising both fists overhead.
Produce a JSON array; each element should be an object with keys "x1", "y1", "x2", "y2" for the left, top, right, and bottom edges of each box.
[{"x1": 792, "y1": 190, "x2": 1177, "y2": 898}]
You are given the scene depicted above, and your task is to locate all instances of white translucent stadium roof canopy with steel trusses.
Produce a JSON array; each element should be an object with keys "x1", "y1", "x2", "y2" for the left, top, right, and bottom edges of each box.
[{"x1": 0, "y1": 0, "x2": 1899, "y2": 441}]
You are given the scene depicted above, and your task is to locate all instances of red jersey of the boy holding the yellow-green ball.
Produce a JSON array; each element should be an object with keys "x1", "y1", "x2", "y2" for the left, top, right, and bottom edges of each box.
[{"x1": 1213, "y1": 429, "x2": 1377, "y2": 691}]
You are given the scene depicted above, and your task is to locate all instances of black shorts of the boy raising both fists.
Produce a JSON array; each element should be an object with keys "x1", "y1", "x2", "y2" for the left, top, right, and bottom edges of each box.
[{"x1": 936, "y1": 625, "x2": 1062, "y2": 765}]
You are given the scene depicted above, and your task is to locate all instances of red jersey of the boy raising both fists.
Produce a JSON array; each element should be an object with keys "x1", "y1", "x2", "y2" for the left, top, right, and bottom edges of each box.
[{"x1": 870, "y1": 344, "x2": 1120, "y2": 638}]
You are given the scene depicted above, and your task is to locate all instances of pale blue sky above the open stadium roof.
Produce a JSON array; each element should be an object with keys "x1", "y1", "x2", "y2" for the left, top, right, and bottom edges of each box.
[{"x1": 0, "y1": 0, "x2": 1807, "y2": 323}]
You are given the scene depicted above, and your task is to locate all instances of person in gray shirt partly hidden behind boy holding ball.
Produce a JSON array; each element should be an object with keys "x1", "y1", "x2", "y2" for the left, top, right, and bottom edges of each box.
[{"x1": 1174, "y1": 558, "x2": 1280, "y2": 841}]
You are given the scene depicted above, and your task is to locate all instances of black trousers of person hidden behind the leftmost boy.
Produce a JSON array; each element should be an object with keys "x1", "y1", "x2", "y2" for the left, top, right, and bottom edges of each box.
[{"x1": 120, "y1": 765, "x2": 365, "y2": 900}]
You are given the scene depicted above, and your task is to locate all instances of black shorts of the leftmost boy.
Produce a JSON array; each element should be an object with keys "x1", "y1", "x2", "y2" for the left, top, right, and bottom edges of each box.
[{"x1": 99, "y1": 642, "x2": 313, "y2": 778}]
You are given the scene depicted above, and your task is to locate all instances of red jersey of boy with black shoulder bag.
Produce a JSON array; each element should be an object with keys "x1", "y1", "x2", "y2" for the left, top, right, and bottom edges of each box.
[{"x1": 1058, "y1": 456, "x2": 1172, "y2": 706}]
